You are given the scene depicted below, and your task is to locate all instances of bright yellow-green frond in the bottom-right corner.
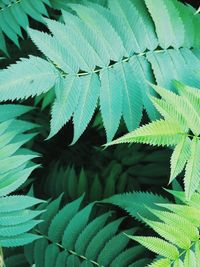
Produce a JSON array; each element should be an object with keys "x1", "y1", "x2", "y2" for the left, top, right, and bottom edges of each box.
[{"x1": 125, "y1": 192, "x2": 200, "y2": 267}]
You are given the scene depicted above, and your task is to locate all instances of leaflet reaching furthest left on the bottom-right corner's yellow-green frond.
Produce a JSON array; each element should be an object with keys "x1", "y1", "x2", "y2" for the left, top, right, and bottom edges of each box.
[{"x1": 128, "y1": 235, "x2": 179, "y2": 260}]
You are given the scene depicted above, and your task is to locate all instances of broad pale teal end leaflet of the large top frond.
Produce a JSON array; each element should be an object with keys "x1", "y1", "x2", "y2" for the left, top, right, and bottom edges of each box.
[{"x1": 0, "y1": 56, "x2": 57, "y2": 101}]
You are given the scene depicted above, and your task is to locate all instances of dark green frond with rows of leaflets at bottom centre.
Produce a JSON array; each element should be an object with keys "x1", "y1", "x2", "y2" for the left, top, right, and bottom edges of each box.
[{"x1": 25, "y1": 197, "x2": 148, "y2": 267}]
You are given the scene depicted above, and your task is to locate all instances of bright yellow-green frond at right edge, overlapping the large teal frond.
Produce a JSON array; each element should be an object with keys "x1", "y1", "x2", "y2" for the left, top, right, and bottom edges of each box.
[{"x1": 110, "y1": 82, "x2": 200, "y2": 199}]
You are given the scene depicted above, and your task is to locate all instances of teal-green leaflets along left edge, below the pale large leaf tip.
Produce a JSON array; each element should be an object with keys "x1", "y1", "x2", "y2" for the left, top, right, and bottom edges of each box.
[{"x1": 0, "y1": 104, "x2": 43, "y2": 247}]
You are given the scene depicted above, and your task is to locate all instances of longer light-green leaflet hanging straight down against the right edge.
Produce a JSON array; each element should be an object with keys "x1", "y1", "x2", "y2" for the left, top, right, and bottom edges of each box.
[{"x1": 184, "y1": 137, "x2": 200, "y2": 199}]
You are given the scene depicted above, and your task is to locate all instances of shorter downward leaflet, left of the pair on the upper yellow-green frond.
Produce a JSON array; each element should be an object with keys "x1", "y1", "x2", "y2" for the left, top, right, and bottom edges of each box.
[{"x1": 169, "y1": 136, "x2": 191, "y2": 183}]
